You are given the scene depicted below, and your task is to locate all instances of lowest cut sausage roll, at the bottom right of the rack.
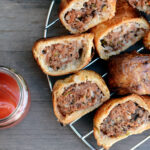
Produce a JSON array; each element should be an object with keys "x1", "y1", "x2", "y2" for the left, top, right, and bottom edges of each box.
[{"x1": 94, "y1": 94, "x2": 150, "y2": 149}]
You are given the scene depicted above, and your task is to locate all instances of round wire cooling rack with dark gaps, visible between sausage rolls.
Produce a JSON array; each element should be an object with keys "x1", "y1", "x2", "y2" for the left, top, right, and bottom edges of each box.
[{"x1": 44, "y1": 0, "x2": 150, "y2": 150}]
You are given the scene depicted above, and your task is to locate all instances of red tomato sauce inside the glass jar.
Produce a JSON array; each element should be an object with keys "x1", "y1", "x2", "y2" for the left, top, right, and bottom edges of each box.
[{"x1": 0, "y1": 72, "x2": 20, "y2": 119}]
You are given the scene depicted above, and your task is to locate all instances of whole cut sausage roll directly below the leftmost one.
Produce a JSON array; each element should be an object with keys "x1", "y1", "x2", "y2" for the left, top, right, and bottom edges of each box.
[{"x1": 52, "y1": 70, "x2": 110, "y2": 125}]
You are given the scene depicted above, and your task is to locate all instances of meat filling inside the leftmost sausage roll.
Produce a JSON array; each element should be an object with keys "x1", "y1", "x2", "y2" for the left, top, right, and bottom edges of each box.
[{"x1": 42, "y1": 41, "x2": 84, "y2": 71}]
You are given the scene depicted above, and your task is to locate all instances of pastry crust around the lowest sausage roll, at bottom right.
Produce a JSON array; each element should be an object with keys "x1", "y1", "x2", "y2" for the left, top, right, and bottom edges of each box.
[{"x1": 93, "y1": 94, "x2": 150, "y2": 149}]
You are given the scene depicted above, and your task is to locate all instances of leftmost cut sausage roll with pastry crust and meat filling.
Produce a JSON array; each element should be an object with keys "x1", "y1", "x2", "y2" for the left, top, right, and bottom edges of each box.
[{"x1": 33, "y1": 33, "x2": 94, "y2": 76}]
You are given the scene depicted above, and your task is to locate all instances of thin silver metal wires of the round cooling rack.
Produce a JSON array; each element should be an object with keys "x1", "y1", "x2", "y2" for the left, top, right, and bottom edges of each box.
[{"x1": 44, "y1": 0, "x2": 150, "y2": 150}]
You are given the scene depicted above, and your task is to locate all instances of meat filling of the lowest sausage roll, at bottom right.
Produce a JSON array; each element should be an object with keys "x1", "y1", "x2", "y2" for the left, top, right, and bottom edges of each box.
[{"x1": 100, "y1": 101, "x2": 150, "y2": 137}]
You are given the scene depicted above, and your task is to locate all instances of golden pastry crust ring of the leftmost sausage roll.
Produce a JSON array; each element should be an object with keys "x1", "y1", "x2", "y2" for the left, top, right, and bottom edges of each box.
[{"x1": 32, "y1": 33, "x2": 94, "y2": 76}]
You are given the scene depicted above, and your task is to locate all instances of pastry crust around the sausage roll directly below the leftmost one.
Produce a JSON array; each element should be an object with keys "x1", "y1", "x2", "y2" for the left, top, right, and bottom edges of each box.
[{"x1": 52, "y1": 70, "x2": 110, "y2": 125}]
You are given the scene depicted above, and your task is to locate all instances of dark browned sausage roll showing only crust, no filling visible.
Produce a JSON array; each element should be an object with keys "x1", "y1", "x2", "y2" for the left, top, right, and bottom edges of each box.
[{"x1": 108, "y1": 51, "x2": 150, "y2": 95}]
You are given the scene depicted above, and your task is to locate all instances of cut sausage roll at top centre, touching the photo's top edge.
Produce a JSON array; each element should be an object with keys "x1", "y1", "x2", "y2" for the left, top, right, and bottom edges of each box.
[{"x1": 59, "y1": 0, "x2": 116, "y2": 33}]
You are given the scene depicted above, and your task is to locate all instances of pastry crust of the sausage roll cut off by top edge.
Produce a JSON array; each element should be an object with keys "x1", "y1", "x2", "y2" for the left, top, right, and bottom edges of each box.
[{"x1": 59, "y1": 0, "x2": 116, "y2": 34}]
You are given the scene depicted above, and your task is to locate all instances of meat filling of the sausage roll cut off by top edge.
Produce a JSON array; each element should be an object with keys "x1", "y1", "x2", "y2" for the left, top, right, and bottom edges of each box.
[{"x1": 65, "y1": 0, "x2": 108, "y2": 31}]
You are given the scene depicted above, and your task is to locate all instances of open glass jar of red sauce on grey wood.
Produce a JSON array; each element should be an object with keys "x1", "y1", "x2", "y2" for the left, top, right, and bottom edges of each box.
[{"x1": 0, "y1": 67, "x2": 30, "y2": 129}]
